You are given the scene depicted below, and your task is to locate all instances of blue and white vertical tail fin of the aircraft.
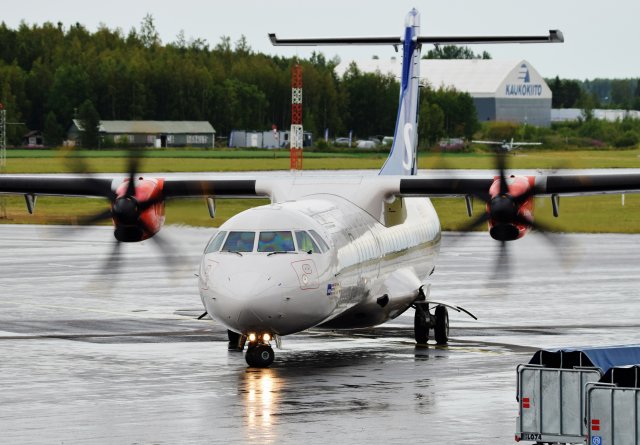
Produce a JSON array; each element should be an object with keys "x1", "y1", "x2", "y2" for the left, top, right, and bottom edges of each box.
[{"x1": 380, "y1": 9, "x2": 422, "y2": 175}]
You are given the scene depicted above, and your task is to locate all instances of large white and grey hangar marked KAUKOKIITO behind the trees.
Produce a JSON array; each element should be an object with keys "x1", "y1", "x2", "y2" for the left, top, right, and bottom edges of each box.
[{"x1": 336, "y1": 59, "x2": 551, "y2": 127}]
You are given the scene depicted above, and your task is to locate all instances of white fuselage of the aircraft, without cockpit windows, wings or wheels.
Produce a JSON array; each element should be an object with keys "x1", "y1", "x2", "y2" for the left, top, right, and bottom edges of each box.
[{"x1": 199, "y1": 183, "x2": 440, "y2": 335}]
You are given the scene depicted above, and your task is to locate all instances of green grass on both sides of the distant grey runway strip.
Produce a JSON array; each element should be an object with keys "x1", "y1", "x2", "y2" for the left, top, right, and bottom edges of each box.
[{"x1": 0, "y1": 150, "x2": 640, "y2": 233}]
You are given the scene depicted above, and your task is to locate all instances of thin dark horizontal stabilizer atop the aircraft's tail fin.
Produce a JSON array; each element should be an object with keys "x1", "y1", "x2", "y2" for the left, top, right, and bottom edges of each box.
[{"x1": 269, "y1": 29, "x2": 564, "y2": 46}]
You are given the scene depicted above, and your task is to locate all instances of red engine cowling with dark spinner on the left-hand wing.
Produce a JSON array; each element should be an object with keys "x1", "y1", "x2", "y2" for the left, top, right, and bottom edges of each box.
[{"x1": 111, "y1": 177, "x2": 165, "y2": 242}]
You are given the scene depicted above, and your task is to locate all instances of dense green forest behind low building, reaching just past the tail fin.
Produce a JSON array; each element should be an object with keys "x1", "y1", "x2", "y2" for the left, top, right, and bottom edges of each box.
[{"x1": 0, "y1": 15, "x2": 478, "y2": 145}]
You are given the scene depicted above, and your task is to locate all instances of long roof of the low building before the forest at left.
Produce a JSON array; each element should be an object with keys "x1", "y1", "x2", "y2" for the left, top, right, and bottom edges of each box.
[{"x1": 73, "y1": 119, "x2": 216, "y2": 134}]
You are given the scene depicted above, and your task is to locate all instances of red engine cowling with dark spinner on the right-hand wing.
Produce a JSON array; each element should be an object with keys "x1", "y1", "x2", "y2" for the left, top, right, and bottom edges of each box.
[{"x1": 487, "y1": 175, "x2": 535, "y2": 241}]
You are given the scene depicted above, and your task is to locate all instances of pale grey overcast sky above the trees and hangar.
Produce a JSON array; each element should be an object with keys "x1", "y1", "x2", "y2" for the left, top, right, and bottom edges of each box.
[{"x1": 5, "y1": 0, "x2": 640, "y2": 79}]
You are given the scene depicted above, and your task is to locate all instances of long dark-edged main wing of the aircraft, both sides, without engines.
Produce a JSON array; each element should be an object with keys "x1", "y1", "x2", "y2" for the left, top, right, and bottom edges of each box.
[{"x1": 0, "y1": 173, "x2": 640, "y2": 199}]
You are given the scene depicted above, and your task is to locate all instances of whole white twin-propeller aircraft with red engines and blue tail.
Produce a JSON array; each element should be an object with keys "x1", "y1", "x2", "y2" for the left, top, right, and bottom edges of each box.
[{"x1": 0, "y1": 10, "x2": 640, "y2": 367}]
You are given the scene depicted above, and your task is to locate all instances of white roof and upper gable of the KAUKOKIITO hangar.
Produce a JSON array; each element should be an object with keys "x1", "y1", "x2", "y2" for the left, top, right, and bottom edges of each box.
[{"x1": 336, "y1": 58, "x2": 551, "y2": 98}]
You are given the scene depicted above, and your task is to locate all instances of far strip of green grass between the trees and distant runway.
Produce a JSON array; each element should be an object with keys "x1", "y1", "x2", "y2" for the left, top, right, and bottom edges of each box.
[{"x1": 7, "y1": 149, "x2": 640, "y2": 173}]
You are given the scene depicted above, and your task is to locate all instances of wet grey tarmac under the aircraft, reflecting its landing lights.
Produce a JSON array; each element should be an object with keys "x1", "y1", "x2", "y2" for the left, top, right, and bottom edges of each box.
[{"x1": 0, "y1": 225, "x2": 640, "y2": 444}]
